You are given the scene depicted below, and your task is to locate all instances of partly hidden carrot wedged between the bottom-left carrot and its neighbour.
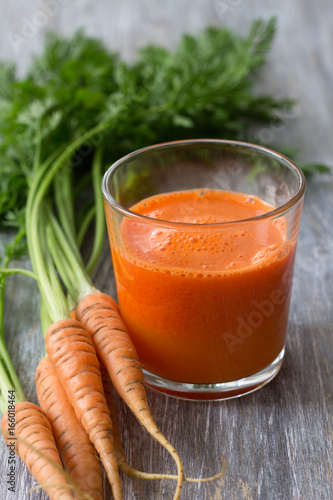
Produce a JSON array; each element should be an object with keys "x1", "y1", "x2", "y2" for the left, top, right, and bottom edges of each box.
[{"x1": 35, "y1": 356, "x2": 103, "y2": 500}]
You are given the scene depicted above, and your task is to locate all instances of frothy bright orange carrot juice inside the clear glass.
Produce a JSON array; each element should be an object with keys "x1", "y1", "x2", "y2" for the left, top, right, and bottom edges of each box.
[{"x1": 107, "y1": 189, "x2": 296, "y2": 384}]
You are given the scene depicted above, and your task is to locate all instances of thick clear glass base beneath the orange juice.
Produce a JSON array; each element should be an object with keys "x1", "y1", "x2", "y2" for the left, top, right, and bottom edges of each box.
[{"x1": 143, "y1": 348, "x2": 285, "y2": 401}]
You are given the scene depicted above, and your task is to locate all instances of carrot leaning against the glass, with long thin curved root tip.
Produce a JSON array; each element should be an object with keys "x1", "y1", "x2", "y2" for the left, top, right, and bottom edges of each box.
[{"x1": 76, "y1": 292, "x2": 184, "y2": 499}]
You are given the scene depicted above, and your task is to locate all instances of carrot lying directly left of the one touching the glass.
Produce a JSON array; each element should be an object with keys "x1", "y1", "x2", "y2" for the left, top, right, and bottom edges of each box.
[{"x1": 45, "y1": 319, "x2": 122, "y2": 500}]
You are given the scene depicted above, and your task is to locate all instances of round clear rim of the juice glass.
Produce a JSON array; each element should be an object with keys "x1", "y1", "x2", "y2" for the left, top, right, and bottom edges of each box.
[{"x1": 101, "y1": 139, "x2": 305, "y2": 228}]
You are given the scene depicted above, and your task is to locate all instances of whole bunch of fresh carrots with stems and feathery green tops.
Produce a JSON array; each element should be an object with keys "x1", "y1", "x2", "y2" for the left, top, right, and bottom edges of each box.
[{"x1": 0, "y1": 20, "x2": 300, "y2": 500}]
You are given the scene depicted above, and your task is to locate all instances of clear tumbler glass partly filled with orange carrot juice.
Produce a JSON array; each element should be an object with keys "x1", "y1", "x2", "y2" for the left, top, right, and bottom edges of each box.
[{"x1": 102, "y1": 139, "x2": 305, "y2": 400}]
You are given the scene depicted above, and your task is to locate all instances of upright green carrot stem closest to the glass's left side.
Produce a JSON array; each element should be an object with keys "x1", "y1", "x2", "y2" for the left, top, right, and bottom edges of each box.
[{"x1": 86, "y1": 147, "x2": 105, "y2": 275}]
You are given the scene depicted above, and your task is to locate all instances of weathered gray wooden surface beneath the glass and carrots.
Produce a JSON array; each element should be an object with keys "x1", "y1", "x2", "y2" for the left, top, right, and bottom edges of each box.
[{"x1": 0, "y1": 0, "x2": 333, "y2": 500}]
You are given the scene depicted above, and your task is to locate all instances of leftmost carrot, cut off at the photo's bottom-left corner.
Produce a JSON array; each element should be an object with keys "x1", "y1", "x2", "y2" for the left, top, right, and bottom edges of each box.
[{"x1": 1, "y1": 402, "x2": 73, "y2": 500}]
